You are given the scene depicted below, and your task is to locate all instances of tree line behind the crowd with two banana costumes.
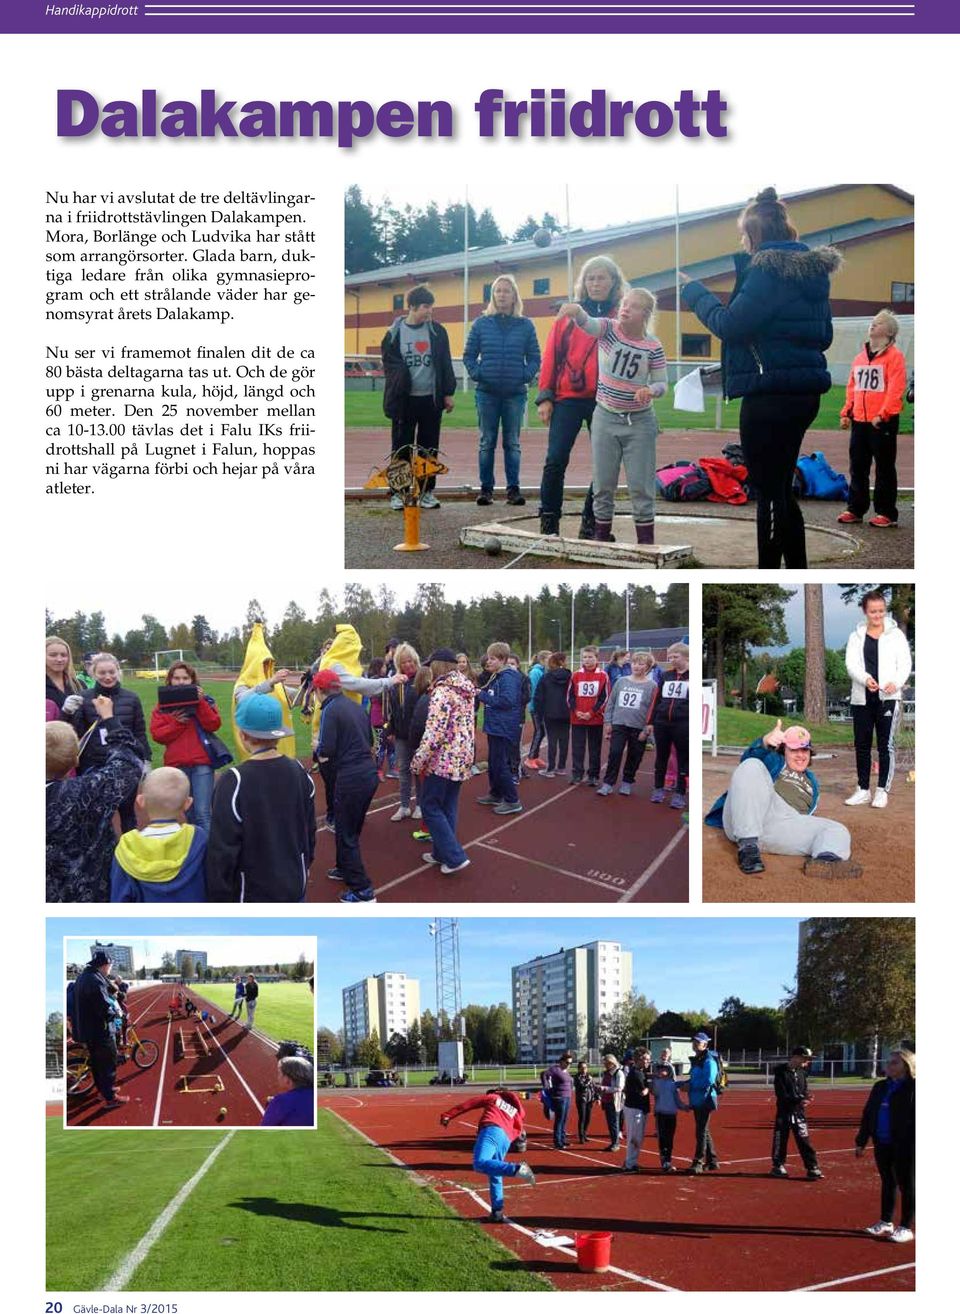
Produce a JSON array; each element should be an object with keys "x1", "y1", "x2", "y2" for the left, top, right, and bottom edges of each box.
[{"x1": 46, "y1": 583, "x2": 688, "y2": 670}]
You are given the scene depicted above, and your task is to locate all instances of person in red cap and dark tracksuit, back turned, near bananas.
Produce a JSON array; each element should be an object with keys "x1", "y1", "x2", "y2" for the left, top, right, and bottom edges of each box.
[{"x1": 314, "y1": 670, "x2": 380, "y2": 903}]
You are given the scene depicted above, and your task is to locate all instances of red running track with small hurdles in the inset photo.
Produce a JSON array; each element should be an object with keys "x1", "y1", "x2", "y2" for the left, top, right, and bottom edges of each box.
[{"x1": 66, "y1": 986, "x2": 291, "y2": 1127}]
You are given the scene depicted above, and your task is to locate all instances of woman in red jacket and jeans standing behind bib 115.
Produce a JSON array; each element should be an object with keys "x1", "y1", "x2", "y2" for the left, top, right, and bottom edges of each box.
[{"x1": 537, "y1": 255, "x2": 630, "y2": 539}]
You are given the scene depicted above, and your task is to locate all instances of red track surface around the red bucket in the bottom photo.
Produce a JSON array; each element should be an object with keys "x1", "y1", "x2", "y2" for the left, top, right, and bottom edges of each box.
[{"x1": 320, "y1": 1088, "x2": 915, "y2": 1292}]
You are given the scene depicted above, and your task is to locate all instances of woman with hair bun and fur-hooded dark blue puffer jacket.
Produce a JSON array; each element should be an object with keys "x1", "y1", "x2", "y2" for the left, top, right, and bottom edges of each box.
[{"x1": 680, "y1": 187, "x2": 840, "y2": 570}]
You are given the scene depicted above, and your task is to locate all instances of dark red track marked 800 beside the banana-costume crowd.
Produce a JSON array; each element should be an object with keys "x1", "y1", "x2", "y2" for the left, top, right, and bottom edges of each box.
[{"x1": 306, "y1": 732, "x2": 688, "y2": 903}]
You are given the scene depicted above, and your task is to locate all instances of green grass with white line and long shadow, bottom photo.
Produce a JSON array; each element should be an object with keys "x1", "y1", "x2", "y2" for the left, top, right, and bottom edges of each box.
[{"x1": 46, "y1": 1110, "x2": 549, "y2": 1292}]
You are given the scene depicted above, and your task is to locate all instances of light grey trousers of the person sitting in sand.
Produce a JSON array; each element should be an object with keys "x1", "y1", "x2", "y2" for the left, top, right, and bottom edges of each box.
[{"x1": 724, "y1": 758, "x2": 850, "y2": 859}]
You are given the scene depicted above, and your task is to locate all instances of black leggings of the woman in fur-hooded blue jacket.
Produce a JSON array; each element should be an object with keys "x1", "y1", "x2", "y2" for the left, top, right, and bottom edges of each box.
[{"x1": 739, "y1": 393, "x2": 819, "y2": 570}]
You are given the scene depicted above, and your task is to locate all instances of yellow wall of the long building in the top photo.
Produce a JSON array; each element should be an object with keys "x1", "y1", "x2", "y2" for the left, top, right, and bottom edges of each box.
[{"x1": 344, "y1": 184, "x2": 914, "y2": 359}]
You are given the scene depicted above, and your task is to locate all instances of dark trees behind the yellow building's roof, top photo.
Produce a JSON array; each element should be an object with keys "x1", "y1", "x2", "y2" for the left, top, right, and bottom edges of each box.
[{"x1": 344, "y1": 185, "x2": 561, "y2": 273}]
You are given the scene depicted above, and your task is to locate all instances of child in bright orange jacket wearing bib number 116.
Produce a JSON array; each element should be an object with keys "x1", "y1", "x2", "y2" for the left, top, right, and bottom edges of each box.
[{"x1": 837, "y1": 310, "x2": 906, "y2": 530}]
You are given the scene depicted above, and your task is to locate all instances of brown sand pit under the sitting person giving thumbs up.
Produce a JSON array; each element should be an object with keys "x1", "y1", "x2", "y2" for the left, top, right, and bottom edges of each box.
[{"x1": 703, "y1": 749, "x2": 915, "y2": 903}]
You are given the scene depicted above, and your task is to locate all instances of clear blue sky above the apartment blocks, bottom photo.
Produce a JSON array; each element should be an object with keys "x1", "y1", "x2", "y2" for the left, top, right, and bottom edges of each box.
[{"x1": 47, "y1": 915, "x2": 798, "y2": 1030}]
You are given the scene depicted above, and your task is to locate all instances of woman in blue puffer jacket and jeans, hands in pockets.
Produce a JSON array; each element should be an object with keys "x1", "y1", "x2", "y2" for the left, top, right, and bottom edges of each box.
[{"x1": 464, "y1": 273, "x2": 540, "y2": 506}]
